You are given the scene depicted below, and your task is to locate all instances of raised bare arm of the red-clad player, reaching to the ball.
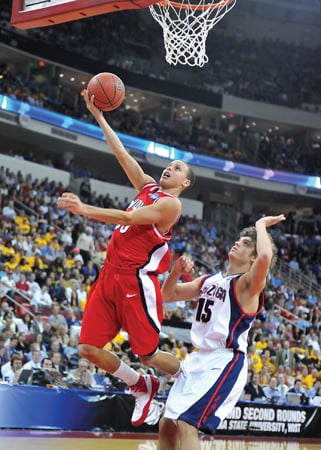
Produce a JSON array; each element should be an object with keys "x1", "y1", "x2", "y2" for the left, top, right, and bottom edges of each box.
[{"x1": 81, "y1": 89, "x2": 154, "y2": 191}]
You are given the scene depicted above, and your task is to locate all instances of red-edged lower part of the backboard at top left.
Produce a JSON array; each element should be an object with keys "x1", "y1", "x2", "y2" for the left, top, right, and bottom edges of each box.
[{"x1": 11, "y1": 0, "x2": 156, "y2": 30}]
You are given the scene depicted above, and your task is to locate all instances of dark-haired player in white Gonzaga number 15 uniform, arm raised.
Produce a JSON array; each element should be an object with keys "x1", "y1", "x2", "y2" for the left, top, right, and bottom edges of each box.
[{"x1": 158, "y1": 214, "x2": 285, "y2": 450}]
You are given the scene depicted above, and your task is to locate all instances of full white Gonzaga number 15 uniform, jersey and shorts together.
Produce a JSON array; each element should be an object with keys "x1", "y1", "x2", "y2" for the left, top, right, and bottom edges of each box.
[{"x1": 164, "y1": 273, "x2": 263, "y2": 434}]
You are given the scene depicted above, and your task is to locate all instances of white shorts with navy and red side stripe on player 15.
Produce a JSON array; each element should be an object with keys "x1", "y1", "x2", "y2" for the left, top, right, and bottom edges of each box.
[{"x1": 164, "y1": 349, "x2": 247, "y2": 434}]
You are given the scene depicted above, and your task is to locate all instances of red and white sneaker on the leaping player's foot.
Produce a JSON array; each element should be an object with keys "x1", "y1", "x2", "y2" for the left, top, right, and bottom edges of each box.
[{"x1": 129, "y1": 375, "x2": 159, "y2": 427}]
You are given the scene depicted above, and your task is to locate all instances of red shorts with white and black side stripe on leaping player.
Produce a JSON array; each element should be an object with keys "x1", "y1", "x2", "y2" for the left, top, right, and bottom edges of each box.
[{"x1": 79, "y1": 263, "x2": 163, "y2": 356}]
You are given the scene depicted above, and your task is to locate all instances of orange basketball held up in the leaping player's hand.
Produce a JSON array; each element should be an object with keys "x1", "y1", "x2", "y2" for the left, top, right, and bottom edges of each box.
[{"x1": 87, "y1": 72, "x2": 125, "y2": 111}]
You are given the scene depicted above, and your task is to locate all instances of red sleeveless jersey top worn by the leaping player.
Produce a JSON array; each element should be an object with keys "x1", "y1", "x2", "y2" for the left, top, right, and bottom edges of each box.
[{"x1": 106, "y1": 183, "x2": 173, "y2": 274}]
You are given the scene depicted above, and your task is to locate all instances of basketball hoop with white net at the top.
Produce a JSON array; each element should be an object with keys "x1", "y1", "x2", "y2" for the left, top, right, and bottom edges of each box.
[{"x1": 149, "y1": 0, "x2": 236, "y2": 67}]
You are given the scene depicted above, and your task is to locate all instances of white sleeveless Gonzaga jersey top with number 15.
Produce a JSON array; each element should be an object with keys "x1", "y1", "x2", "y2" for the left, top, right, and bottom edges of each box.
[{"x1": 191, "y1": 272, "x2": 264, "y2": 353}]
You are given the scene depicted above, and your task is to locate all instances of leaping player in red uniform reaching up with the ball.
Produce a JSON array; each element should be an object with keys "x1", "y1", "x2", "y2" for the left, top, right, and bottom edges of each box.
[{"x1": 57, "y1": 90, "x2": 195, "y2": 426}]
